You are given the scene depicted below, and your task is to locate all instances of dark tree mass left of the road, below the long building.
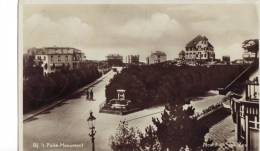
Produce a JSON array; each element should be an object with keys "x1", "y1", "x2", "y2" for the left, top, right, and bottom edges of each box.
[{"x1": 23, "y1": 63, "x2": 101, "y2": 113}]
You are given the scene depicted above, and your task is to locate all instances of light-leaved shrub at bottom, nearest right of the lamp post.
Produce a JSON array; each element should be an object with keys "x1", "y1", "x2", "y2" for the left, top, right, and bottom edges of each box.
[{"x1": 110, "y1": 121, "x2": 140, "y2": 151}]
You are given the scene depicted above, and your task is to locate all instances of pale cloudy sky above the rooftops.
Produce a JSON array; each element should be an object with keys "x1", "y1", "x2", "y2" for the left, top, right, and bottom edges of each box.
[{"x1": 22, "y1": 3, "x2": 259, "y2": 61}]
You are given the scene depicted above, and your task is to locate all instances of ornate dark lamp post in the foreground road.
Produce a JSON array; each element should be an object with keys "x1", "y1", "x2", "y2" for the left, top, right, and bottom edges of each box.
[{"x1": 87, "y1": 111, "x2": 96, "y2": 151}]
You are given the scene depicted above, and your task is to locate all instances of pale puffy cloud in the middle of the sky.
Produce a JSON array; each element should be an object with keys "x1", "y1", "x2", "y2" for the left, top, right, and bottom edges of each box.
[{"x1": 117, "y1": 13, "x2": 182, "y2": 40}]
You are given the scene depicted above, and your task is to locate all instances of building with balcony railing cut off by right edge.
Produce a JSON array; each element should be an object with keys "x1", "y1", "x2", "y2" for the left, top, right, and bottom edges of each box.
[{"x1": 230, "y1": 77, "x2": 259, "y2": 151}]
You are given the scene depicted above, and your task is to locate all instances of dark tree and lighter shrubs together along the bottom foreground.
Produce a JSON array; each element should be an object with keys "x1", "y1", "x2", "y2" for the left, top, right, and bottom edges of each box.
[{"x1": 110, "y1": 105, "x2": 219, "y2": 151}]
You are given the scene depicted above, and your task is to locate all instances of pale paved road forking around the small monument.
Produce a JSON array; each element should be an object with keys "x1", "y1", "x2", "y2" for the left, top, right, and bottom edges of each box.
[{"x1": 23, "y1": 71, "x2": 230, "y2": 151}]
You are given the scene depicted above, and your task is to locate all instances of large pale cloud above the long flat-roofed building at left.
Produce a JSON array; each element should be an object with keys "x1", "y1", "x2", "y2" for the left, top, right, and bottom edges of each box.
[{"x1": 23, "y1": 14, "x2": 93, "y2": 51}]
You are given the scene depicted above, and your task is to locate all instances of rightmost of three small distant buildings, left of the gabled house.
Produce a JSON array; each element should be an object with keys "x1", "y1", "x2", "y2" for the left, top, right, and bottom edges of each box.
[{"x1": 146, "y1": 51, "x2": 167, "y2": 64}]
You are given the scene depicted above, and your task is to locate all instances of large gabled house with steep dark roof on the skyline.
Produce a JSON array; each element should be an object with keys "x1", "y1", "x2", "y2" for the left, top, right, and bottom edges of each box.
[{"x1": 185, "y1": 35, "x2": 215, "y2": 62}]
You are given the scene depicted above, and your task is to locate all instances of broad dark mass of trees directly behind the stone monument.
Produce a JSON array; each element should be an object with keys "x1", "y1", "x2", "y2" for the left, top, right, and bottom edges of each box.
[{"x1": 106, "y1": 63, "x2": 247, "y2": 107}]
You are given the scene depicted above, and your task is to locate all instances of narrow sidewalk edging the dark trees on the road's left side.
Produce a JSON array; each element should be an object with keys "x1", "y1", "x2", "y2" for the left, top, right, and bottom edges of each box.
[{"x1": 23, "y1": 70, "x2": 113, "y2": 121}]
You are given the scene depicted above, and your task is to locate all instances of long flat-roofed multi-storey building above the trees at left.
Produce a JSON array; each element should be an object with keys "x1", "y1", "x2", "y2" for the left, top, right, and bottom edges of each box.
[{"x1": 28, "y1": 47, "x2": 85, "y2": 74}]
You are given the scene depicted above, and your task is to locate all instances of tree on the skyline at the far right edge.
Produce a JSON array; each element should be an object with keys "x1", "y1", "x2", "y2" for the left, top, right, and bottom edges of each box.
[{"x1": 242, "y1": 39, "x2": 259, "y2": 58}]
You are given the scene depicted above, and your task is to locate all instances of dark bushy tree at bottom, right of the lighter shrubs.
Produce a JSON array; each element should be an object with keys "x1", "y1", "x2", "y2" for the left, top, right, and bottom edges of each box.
[{"x1": 152, "y1": 105, "x2": 206, "y2": 151}]
